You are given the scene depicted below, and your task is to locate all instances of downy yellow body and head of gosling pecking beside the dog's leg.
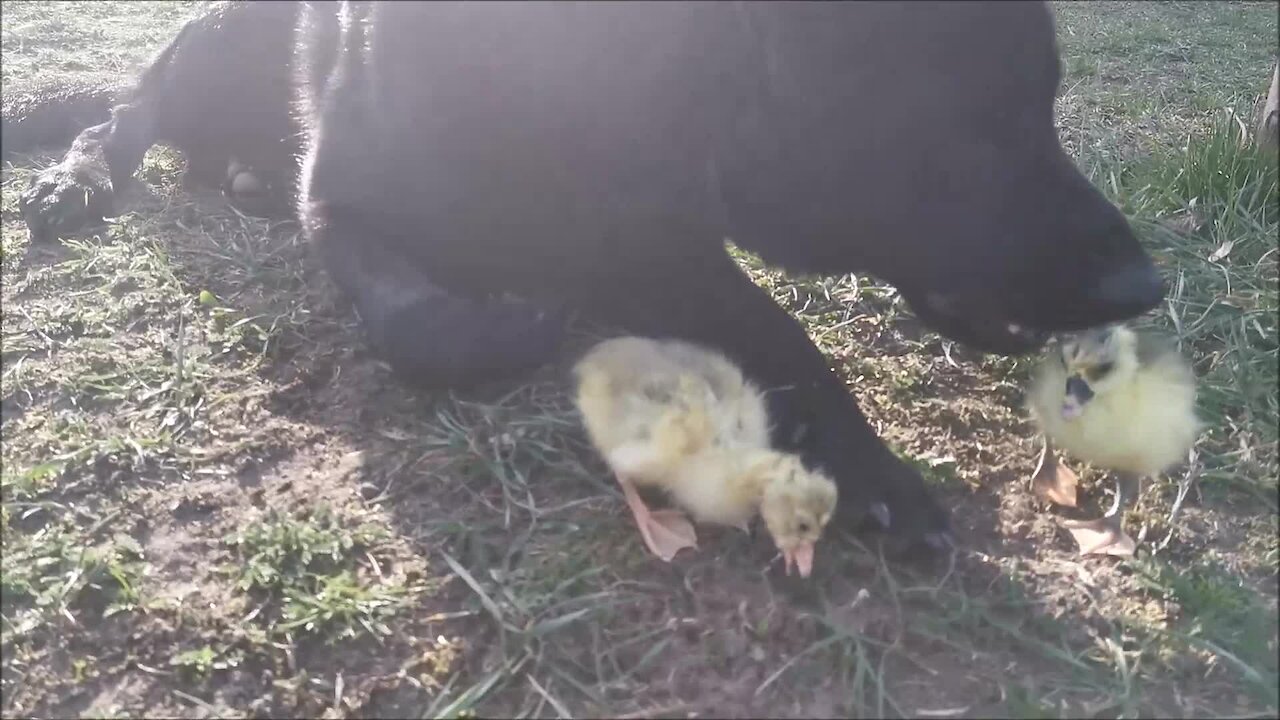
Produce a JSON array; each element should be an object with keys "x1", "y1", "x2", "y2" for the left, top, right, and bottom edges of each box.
[{"x1": 575, "y1": 337, "x2": 836, "y2": 550}]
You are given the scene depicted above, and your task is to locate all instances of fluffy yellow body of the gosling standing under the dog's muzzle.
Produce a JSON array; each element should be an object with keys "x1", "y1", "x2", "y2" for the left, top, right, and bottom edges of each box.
[{"x1": 1027, "y1": 327, "x2": 1201, "y2": 477}]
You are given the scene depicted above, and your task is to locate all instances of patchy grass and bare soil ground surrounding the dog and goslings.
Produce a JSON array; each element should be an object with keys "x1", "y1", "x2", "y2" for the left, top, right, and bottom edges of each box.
[{"x1": 0, "y1": 3, "x2": 1280, "y2": 717}]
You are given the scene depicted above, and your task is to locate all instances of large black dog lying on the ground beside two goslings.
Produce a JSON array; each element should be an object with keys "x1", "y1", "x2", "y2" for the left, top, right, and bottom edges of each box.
[{"x1": 15, "y1": 3, "x2": 1162, "y2": 544}]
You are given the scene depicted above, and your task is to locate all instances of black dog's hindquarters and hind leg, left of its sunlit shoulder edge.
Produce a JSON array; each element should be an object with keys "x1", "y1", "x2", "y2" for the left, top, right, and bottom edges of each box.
[{"x1": 16, "y1": 1, "x2": 302, "y2": 241}]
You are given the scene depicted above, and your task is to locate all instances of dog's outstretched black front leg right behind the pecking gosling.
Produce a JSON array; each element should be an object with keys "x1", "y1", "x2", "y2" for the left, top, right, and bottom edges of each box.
[{"x1": 580, "y1": 256, "x2": 948, "y2": 556}]
